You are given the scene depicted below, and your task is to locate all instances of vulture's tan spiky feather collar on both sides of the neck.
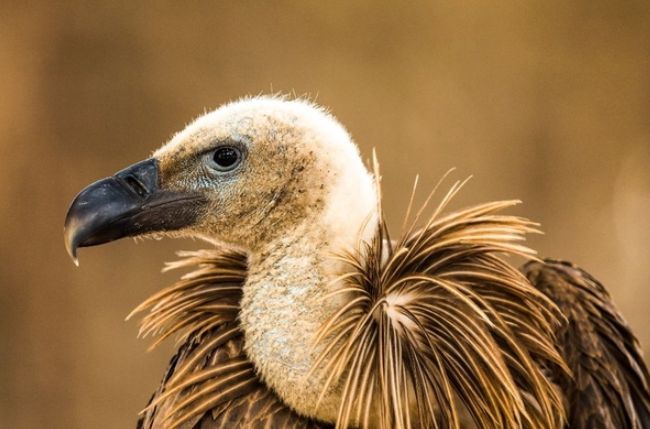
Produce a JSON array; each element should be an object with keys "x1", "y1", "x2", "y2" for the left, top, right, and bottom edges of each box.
[{"x1": 132, "y1": 176, "x2": 566, "y2": 429}]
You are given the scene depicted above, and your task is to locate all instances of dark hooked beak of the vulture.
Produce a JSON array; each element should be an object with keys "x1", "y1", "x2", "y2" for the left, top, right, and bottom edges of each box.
[{"x1": 63, "y1": 158, "x2": 206, "y2": 265}]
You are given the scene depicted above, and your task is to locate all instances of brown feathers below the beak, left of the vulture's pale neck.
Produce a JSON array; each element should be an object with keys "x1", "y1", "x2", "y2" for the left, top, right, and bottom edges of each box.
[{"x1": 134, "y1": 249, "x2": 327, "y2": 429}]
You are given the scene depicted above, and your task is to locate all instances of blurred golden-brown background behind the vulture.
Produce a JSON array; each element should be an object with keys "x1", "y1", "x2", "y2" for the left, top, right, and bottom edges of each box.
[{"x1": 0, "y1": 0, "x2": 650, "y2": 429}]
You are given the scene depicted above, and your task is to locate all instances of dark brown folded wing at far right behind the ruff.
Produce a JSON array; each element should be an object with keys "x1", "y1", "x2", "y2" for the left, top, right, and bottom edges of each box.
[{"x1": 523, "y1": 259, "x2": 650, "y2": 429}]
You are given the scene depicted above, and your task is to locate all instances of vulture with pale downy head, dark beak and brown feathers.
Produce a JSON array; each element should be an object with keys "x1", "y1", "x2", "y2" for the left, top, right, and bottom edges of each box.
[{"x1": 64, "y1": 96, "x2": 650, "y2": 429}]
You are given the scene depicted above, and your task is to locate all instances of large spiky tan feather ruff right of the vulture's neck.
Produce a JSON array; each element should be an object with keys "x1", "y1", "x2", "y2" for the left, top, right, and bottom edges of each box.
[{"x1": 314, "y1": 182, "x2": 568, "y2": 429}]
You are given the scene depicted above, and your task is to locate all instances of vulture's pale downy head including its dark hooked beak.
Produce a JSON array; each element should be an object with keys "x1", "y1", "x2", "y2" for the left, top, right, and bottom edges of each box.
[{"x1": 65, "y1": 97, "x2": 376, "y2": 258}]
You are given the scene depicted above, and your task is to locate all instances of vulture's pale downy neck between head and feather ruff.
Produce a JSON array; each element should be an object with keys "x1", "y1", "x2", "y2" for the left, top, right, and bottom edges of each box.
[{"x1": 240, "y1": 176, "x2": 378, "y2": 422}]
